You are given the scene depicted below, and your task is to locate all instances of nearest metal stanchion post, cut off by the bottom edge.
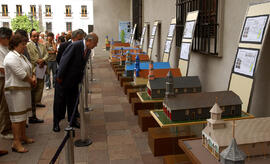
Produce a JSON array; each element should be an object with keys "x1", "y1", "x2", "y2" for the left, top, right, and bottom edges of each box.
[{"x1": 65, "y1": 127, "x2": 74, "y2": 164}]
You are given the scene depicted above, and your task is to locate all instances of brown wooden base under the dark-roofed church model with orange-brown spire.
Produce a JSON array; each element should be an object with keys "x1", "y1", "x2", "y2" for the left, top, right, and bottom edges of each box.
[{"x1": 131, "y1": 98, "x2": 162, "y2": 115}]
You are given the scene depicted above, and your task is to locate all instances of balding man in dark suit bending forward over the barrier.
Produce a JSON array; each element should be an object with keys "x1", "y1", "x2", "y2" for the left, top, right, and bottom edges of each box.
[{"x1": 53, "y1": 33, "x2": 98, "y2": 132}]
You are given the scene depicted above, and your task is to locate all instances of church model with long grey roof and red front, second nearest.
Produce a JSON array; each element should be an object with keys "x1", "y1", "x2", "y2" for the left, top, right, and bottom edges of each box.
[{"x1": 163, "y1": 77, "x2": 242, "y2": 121}]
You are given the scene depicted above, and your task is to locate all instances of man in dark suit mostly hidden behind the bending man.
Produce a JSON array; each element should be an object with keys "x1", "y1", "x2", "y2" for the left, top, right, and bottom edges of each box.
[{"x1": 56, "y1": 30, "x2": 84, "y2": 64}]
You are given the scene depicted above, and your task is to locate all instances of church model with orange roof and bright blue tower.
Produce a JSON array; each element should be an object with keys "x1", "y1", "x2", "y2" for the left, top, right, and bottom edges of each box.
[{"x1": 133, "y1": 61, "x2": 181, "y2": 86}]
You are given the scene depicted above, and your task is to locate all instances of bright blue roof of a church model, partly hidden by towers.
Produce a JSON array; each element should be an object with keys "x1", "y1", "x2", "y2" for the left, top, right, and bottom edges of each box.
[{"x1": 126, "y1": 62, "x2": 170, "y2": 70}]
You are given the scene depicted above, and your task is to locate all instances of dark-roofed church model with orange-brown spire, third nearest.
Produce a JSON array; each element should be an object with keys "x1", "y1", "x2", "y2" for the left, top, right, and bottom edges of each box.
[{"x1": 147, "y1": 69, "x2": 201, "y2": 99}]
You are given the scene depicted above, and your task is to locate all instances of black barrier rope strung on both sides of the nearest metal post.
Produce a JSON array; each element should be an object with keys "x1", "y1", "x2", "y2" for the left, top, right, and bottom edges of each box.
[{"x1": 50, "y1": 87, "x2": 82, "y2": 164}]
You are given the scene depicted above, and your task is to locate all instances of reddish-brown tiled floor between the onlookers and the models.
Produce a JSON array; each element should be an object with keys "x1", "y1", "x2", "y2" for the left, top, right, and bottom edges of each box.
[{"x1": 0, "y1": 52, "x2": 163, "y2": 164}]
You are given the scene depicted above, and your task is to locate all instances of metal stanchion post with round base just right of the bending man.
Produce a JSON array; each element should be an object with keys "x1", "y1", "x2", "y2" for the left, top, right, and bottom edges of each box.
[{"x1": 75, "y1": 85, "x2": 92, "y2": 147}]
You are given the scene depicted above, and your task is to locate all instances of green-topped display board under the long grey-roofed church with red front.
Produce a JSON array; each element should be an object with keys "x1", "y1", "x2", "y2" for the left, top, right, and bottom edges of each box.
[{"x1": 150, "y1": 109, "x2": 254, "y2": 127}]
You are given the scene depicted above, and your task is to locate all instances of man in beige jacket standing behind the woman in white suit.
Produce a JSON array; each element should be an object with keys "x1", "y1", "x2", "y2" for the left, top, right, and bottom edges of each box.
[{"x1": 27, "y1": 29, "x2": 48, "y2": 123}]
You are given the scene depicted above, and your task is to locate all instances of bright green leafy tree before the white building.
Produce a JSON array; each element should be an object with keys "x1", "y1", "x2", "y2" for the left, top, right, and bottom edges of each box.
[{"x1": 11, "y1": 15, "x2": 39, "y2": 33}]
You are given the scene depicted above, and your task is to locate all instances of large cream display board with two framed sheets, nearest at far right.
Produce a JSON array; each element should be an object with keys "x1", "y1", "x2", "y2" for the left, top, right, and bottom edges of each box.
[{"x1": 228, "y1": 2, "x2": 270, "y2": 112}]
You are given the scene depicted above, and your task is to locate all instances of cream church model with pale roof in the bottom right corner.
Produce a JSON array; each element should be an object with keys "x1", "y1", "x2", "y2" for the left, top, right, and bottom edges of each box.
[{"x1": 202, "y1": 103, "x2": 270, "y2": 161}]
